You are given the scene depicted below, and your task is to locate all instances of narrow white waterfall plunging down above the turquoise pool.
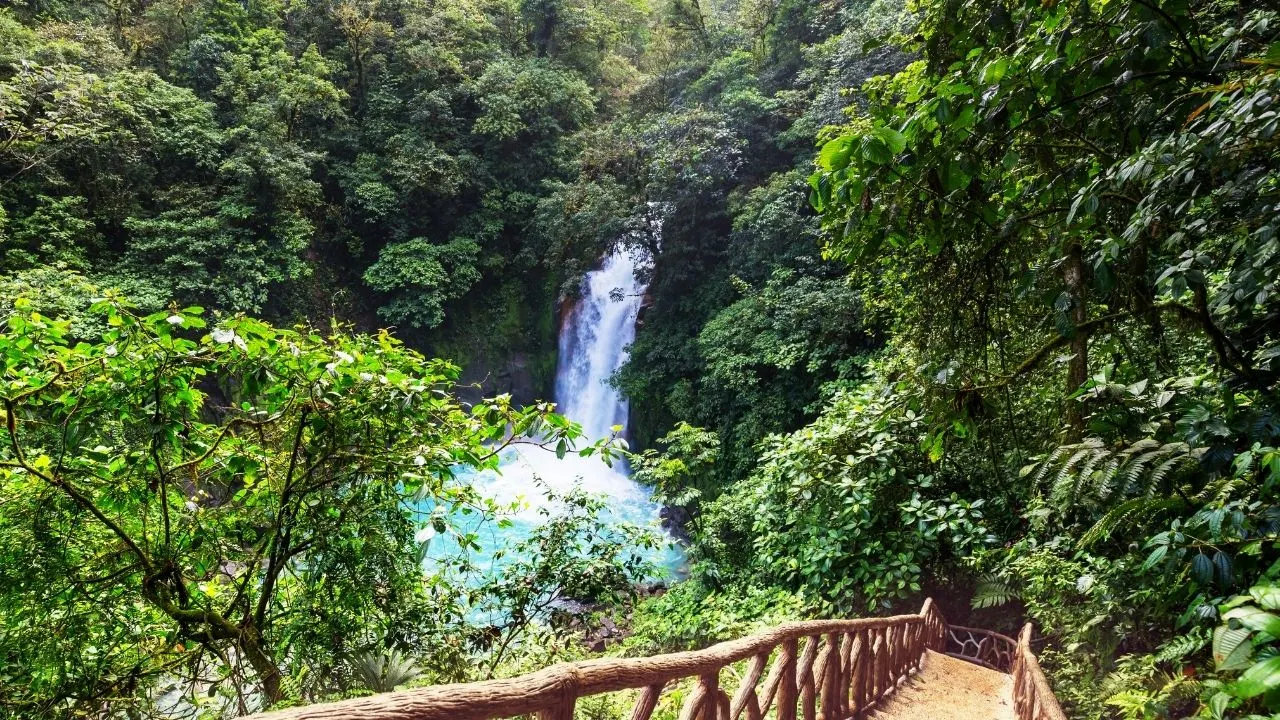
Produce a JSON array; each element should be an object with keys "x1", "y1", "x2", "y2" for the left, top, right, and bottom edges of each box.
[{"x1": 556, "y1": 249, "x2": 648, "y2": 439}]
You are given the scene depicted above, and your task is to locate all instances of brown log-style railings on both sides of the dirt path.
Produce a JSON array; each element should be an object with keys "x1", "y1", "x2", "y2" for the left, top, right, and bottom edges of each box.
[{"x1": 249, "y1": 600, "x2": 1065, "y2": 720}]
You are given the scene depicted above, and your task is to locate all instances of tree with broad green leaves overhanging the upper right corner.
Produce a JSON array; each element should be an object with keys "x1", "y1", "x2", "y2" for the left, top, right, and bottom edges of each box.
[{"x1": 813, "y1": 4, "x2": 1272, "y2": 439}]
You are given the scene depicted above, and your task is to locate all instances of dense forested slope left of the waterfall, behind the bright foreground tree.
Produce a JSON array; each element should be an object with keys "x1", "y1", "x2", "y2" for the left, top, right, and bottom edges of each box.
[{"x1": 0, "y1": 0, "x2": 649, "y2": 400}]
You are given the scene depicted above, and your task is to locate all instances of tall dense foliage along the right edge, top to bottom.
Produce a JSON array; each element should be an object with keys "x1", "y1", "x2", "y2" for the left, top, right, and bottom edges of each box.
[{"x1": 793, "y1": 3, "x2": 1280, "y2": 717}]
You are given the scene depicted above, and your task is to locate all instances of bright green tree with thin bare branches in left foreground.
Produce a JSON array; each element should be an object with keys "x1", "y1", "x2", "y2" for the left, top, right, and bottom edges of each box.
[{"x1": 0, "y1": 300, "x2": 599, "y2": 715}]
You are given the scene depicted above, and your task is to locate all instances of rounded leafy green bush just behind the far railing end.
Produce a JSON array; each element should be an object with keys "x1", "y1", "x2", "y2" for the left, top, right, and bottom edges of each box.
[{"x1": 695, "y1": 383, "x2": 988, "y2": 611}]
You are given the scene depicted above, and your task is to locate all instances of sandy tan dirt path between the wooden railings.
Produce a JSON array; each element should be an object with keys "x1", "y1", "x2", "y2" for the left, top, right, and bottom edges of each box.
[{"x1": 872, "y1": 651, "x2": 1014, "y2": 720}]
